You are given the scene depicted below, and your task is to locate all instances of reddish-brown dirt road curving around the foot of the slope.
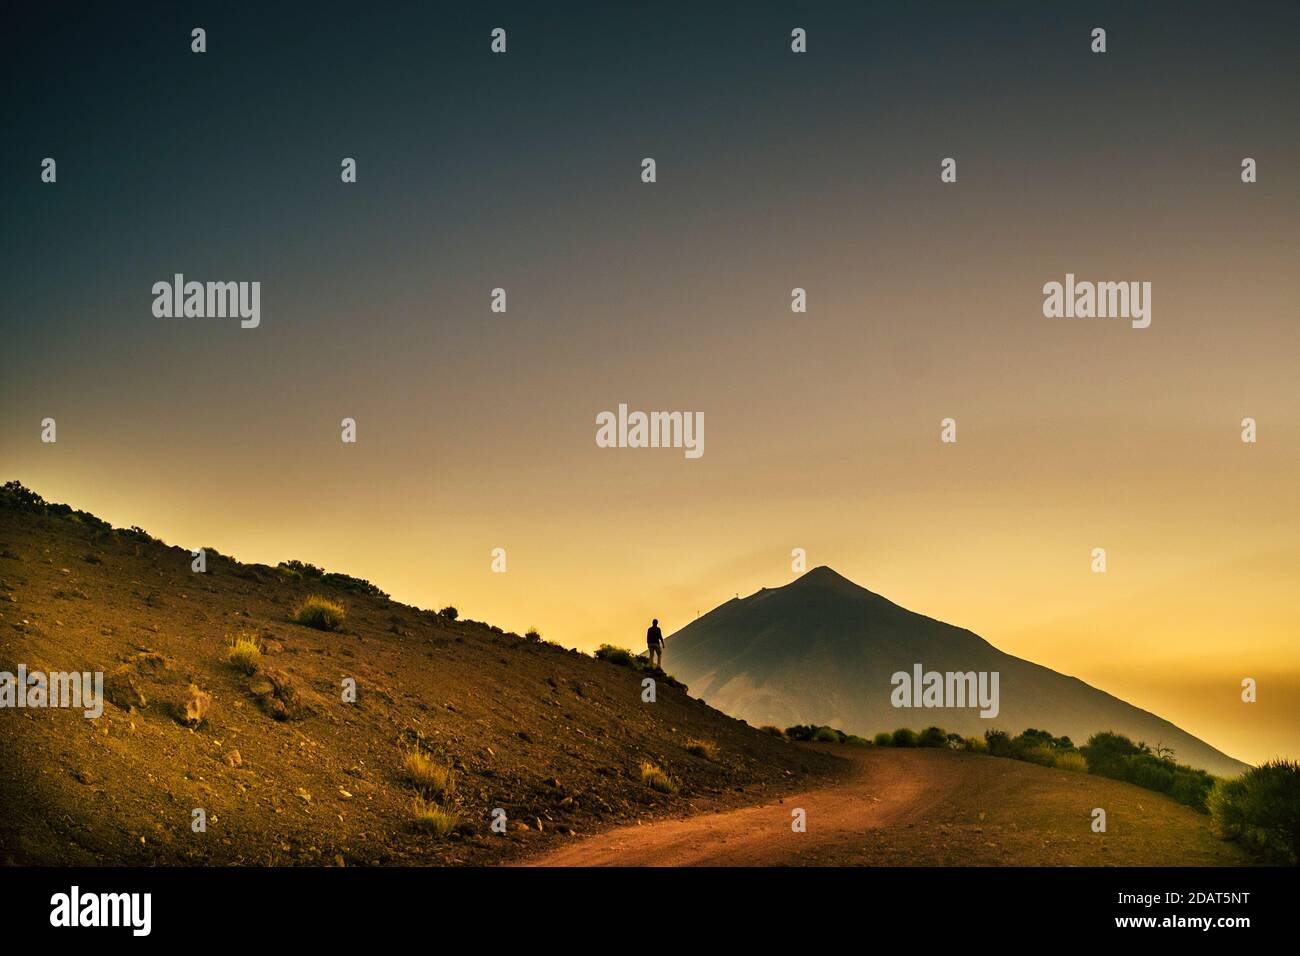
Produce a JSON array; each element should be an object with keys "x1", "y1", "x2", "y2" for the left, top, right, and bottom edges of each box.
[{"x1": 524, "y1": 747, "x2": 1247, "y2": 866}]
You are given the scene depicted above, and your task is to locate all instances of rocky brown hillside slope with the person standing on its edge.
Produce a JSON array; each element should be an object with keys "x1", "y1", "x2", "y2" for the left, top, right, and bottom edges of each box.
[{"x1": 0, "y1": 494, "x2": 845, "y2": 865}]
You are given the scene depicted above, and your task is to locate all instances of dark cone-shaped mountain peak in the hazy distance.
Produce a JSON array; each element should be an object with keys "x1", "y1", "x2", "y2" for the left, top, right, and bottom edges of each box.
[{"x1": 667, "y1": 566, "x2": 1248, "y2": 777}]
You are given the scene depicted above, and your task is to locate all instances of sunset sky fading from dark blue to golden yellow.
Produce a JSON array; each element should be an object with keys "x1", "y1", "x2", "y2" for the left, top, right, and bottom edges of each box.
[{"x1": 0, "y1": 3, "x2": 1300, "y2": 761}]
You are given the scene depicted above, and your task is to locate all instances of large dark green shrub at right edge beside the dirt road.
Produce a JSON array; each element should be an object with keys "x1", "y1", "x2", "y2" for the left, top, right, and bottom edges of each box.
[{"x1": 1208, "y1": 760, "x2": 1300, "y2": 866}]
